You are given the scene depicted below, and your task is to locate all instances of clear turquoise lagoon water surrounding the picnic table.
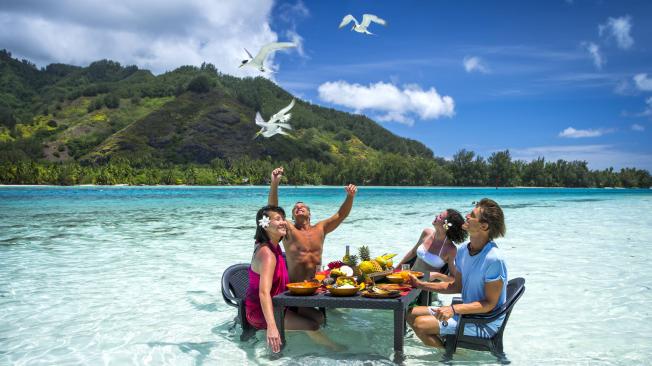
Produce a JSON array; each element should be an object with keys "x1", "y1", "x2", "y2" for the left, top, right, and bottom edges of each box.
[{"x1": 0, "y1": 187, "x2": 652, "y2": 365}]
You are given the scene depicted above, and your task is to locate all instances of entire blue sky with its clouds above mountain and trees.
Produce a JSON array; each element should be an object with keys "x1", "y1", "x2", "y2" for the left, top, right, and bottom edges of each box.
[{"x1": 0, "y1": 0, "x2": 652, "y2": 171}]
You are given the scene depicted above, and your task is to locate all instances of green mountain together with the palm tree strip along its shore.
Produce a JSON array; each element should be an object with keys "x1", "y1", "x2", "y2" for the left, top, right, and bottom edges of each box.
[{"x1": 0, "y1": 50, "x2": 652, "y2": 188}]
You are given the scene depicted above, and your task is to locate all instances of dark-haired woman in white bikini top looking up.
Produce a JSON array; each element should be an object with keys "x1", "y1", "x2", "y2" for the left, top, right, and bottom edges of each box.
[{"x1": 399, "y1": 209, "x2": 467, "y2": 281}]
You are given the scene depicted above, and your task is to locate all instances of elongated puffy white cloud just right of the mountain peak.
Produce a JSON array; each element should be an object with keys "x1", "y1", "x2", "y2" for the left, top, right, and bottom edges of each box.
[{"x1": 318, "y1": 80, "x2": 455, "y2": 125}]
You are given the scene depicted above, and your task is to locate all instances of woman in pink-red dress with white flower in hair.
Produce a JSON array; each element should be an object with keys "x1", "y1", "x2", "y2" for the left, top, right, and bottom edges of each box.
[{"x1": 245, "y1": 206, "x2": 338, "y2": 352}]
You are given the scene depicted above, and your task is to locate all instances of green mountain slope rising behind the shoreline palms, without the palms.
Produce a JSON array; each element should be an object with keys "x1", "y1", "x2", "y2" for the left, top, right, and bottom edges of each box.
[{"x1": 0, "y1": 50, "x2": 433, "y2": 164}]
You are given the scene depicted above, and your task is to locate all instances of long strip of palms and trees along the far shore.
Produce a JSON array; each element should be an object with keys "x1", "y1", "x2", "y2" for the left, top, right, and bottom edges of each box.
[{"x1": 0, "y1": 150, "x2": 652, "y2": 188}]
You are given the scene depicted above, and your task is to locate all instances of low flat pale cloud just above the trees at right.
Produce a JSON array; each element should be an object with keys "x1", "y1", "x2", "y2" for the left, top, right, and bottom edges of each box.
[{"x1": 509, "y1": 145, "x2": 652, "y2": 171}]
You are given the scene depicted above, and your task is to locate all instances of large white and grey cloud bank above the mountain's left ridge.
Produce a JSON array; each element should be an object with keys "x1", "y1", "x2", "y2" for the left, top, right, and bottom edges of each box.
[{"x1": 0, "y1": 0, "x2": 300, "y2": 76}]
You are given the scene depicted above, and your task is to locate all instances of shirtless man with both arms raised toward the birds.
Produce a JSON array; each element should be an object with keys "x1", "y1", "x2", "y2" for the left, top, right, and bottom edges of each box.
[{"x1": 267, "y1": 167, "x2": 358, "y2": 282}]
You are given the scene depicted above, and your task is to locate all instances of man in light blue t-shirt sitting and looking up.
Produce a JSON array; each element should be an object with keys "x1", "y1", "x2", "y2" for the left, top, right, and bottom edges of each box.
[{"x1": 408, "y1": 198, "x2": 507, "y2": 347}]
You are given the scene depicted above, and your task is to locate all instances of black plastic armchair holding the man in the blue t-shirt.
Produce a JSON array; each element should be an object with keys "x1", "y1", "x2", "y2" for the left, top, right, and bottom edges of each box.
[{"x1": 444, "y1": 277, "x2": 525, "y2": 361}]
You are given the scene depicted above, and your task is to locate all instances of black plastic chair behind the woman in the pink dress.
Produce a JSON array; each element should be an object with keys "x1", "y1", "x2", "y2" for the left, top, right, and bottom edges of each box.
[{"x1": 222, "y1": 263, "x2": 256, "y2": 341}]
